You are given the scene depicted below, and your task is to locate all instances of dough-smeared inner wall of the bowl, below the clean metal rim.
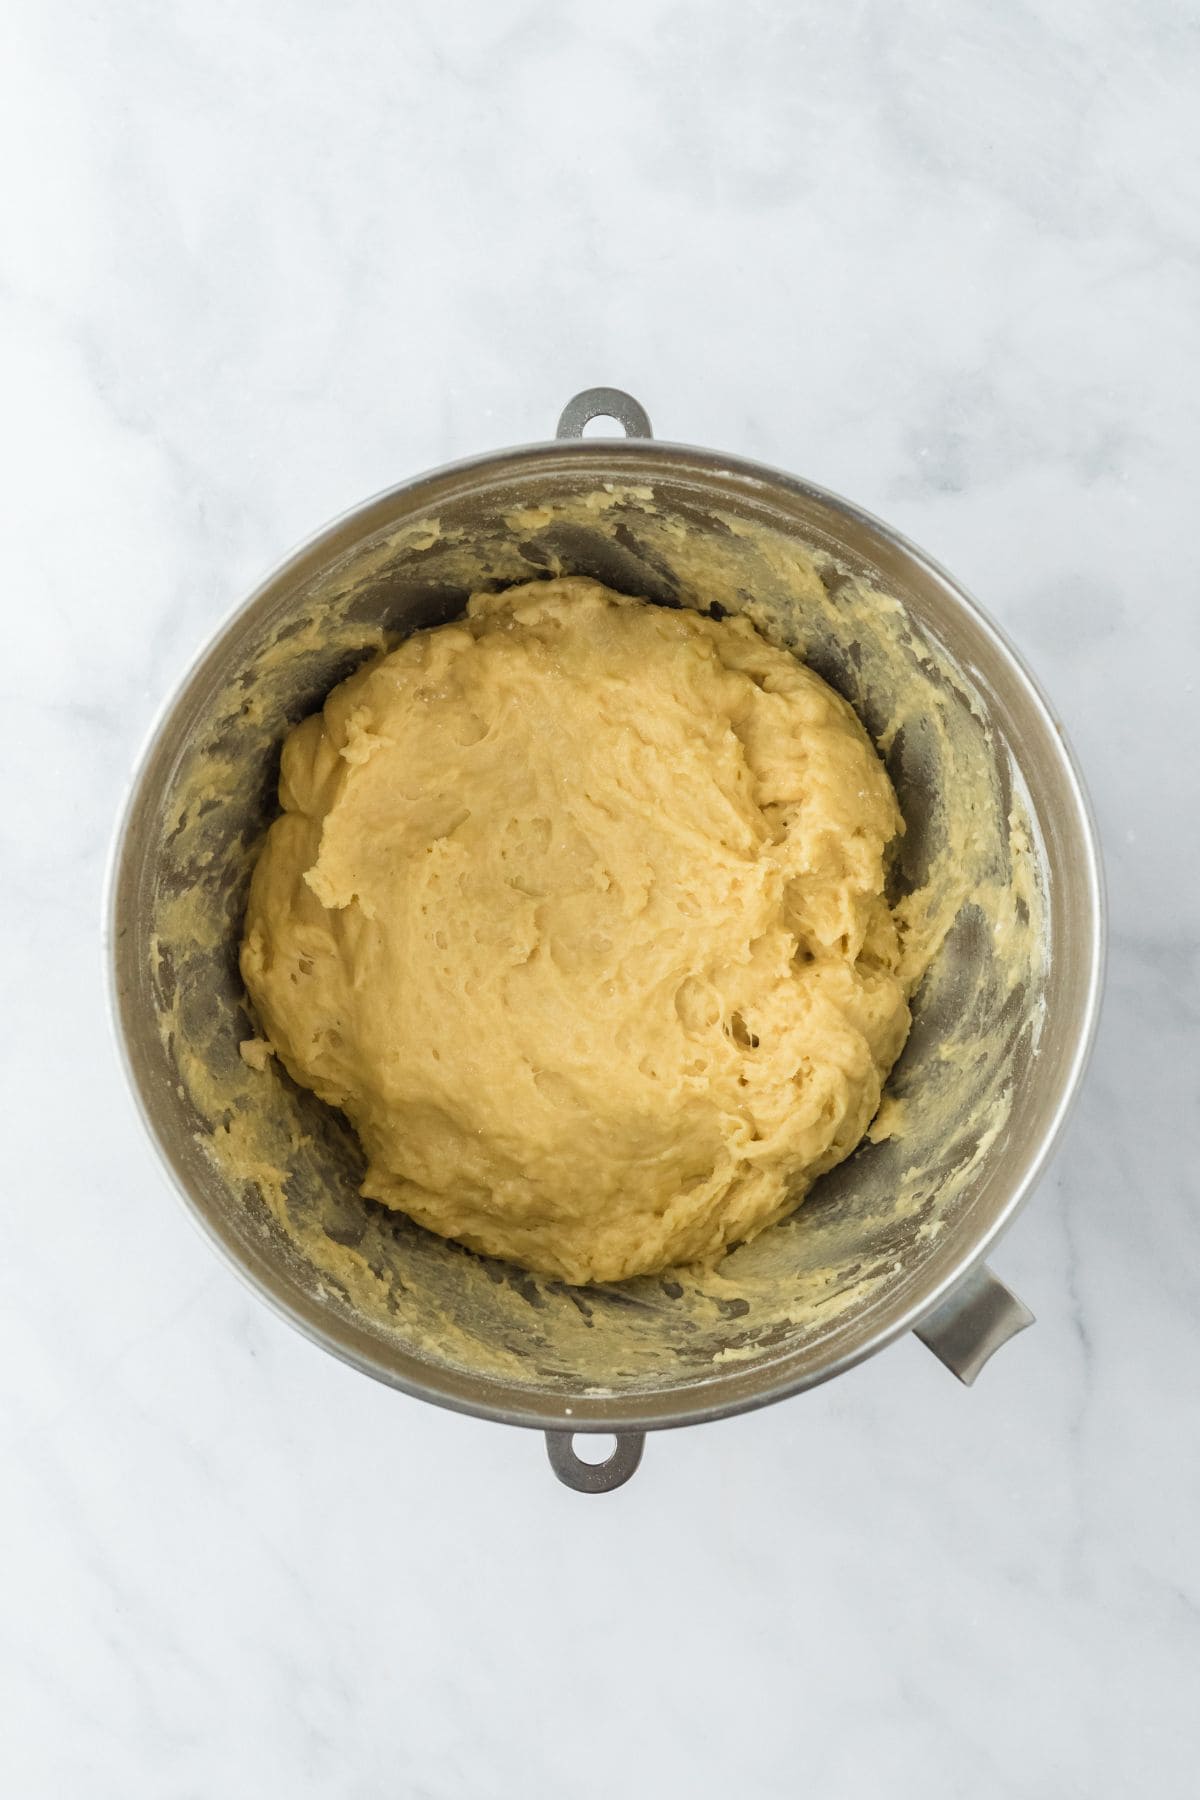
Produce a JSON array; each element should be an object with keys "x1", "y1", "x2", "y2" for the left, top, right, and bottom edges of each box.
[{"x1": 147, "y1": 488, "x2": 1043, "y2": 1393}]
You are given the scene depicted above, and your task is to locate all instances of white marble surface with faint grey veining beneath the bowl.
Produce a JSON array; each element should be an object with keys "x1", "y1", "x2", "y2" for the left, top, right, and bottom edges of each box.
[{"x1": 0, "y1": 0, "x2": 1200, "y2": 1800}]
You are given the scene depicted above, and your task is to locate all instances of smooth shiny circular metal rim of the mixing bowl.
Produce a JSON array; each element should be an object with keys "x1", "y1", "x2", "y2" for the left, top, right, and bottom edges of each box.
[{"x1": 103, "y1": 437, "x2": 1106, "y2": 1433}]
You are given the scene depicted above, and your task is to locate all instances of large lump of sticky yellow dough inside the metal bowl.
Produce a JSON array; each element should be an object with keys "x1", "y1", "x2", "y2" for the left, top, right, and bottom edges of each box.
[{"x1": 241, "y1": 578, "x2": 909, "y2": 1282}]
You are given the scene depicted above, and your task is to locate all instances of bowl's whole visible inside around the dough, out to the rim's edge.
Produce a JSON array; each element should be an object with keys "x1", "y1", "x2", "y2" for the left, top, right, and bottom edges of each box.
[{"x1": 113, "y1": 441, "x2": 1097, "y2": 1426}]
